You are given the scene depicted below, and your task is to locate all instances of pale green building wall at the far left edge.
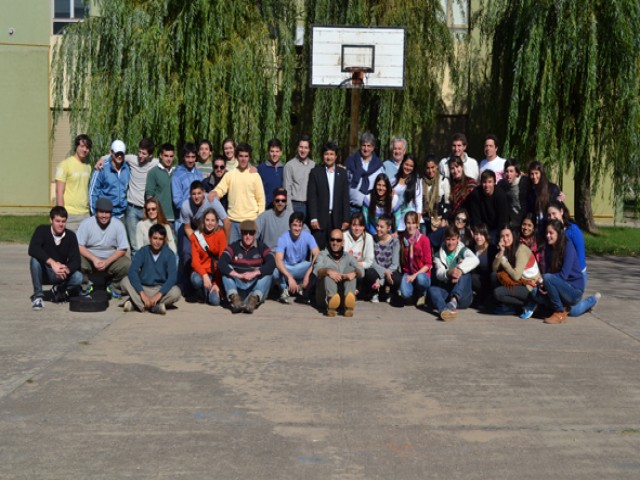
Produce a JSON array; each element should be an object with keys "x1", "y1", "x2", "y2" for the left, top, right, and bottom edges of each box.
[{"x1": 0, "y1": 0, "x2": 51, "y2": 212}]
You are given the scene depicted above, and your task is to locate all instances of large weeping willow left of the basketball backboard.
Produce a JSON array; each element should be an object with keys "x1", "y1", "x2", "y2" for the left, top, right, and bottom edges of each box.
[{"x1": 52, "y1": 0, "x2": 296, "y2": 156}]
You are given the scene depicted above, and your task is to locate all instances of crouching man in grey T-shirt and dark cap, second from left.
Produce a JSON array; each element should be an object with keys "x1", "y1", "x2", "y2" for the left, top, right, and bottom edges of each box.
[{"x1": 78, "y1": 198, "x2": 131, "y2": 298}]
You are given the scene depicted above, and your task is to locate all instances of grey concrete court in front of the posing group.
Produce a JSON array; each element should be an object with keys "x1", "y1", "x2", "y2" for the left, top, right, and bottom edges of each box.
[{"x1": 0, "y1": 245, "x2": 640, "y2": 479}]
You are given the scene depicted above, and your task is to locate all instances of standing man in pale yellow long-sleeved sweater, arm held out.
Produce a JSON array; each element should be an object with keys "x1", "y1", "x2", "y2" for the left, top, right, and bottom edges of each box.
[{"x1": 209, "y1": 143, "x2": 265, "y2": 244}]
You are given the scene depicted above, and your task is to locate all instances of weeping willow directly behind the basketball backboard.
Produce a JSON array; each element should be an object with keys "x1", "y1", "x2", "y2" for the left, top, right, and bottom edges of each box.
[{"x1": 305, "y1": 0, "x2": 459, "y2": 158}]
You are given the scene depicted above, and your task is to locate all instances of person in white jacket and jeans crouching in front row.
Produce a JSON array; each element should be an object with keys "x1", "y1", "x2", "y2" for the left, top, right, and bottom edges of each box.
[{"x1": 429, "y1": 225, "x2": 480, "y2": 322}]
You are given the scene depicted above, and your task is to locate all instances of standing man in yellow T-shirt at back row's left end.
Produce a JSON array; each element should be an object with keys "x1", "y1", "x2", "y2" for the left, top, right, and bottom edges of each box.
[{"x1": 55, "y1": 133, "x2": 93, "y2": 232}]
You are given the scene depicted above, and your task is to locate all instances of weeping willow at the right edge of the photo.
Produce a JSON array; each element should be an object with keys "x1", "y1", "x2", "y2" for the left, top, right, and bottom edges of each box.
[{"x1": 482, "y1": 0, "x2": 640, "y2": 231}]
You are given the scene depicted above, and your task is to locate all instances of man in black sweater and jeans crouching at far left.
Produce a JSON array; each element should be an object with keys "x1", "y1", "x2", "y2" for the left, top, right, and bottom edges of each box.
[{"x1": 29, "y1": 206, "x2": 82, "y2": 310}]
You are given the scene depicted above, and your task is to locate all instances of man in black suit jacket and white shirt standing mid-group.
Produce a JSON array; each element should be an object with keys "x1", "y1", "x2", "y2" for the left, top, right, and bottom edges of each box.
[{"x1": 307, "y1": 142, "x2": 350, "y2": 250}]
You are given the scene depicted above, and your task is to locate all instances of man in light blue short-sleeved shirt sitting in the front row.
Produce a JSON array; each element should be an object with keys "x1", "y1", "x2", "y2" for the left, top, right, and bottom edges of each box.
[{"x1": 273, "y1": 212, "x2": 320, "y2": 303}]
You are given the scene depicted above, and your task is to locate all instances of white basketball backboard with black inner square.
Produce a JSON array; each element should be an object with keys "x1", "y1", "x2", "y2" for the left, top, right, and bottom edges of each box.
[{"x1": 310, "y1": 25, "x2": 405, "y2": 88}]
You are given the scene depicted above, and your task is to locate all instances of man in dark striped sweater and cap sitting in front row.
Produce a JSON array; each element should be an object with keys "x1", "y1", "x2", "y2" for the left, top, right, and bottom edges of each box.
[{"x1": 218, "y1": 218, "x2": 276, "y2": 313}]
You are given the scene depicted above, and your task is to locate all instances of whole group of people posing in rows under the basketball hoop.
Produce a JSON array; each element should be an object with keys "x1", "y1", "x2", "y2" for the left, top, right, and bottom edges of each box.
[{"x1": 29, "y1": 133, "x2": 599, "y2": 323}]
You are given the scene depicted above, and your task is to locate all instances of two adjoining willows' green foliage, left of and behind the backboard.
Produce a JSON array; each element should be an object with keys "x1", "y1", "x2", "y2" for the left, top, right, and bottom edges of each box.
[{"x1": 52, "y1": 0, "x2": 458, "y2": 158}]
